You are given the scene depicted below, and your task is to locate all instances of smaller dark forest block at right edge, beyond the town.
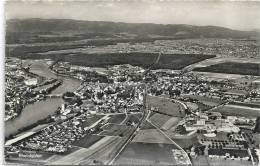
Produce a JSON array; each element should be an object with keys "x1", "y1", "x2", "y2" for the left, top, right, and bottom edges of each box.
[{"x1": 194, "y1": 62, "x2": 260, "y2": 76}]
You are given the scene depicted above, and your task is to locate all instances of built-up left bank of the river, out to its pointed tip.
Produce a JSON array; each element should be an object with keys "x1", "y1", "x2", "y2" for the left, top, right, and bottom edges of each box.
[{"x1": 5, "y1": 58, "x2": 62, "y2": 120}]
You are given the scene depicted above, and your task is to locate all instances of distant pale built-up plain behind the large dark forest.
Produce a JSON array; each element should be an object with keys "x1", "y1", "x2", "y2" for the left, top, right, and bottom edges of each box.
[{"x1": 84, "y1": 38, "x2": 260, "y2": 58}]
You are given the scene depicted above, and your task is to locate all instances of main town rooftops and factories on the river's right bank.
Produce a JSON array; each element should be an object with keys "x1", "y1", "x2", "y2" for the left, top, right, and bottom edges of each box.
[{"x1": 4, "y1": 57, "x2": 259, "y2": 164}]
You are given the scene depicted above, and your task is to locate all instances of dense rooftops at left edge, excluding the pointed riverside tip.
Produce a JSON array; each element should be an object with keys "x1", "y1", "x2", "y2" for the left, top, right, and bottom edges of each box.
[{"x1": 5, "y1": 59, "x2": 37, "y2": 120}]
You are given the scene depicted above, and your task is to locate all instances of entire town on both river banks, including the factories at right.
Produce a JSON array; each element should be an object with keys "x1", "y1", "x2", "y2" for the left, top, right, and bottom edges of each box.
[{"x1": 5, "y1": 55, "x2": 260, "y2": 165}]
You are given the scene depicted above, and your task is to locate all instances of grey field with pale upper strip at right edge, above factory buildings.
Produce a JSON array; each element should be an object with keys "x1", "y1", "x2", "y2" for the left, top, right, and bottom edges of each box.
[{"x1": 214, "y1": 104, "x2": 260, "y2": 117}]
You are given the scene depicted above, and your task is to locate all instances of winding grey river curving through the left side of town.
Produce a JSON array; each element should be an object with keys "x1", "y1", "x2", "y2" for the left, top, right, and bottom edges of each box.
[{"x1": 5, "y1": 60, "x2": 81, "y2": 137}]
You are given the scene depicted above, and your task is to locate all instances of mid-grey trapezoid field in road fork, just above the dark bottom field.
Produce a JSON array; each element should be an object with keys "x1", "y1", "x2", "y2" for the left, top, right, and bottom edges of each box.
[{"x1": 132, "y1": 129, "x2": 172, "y2": 144}]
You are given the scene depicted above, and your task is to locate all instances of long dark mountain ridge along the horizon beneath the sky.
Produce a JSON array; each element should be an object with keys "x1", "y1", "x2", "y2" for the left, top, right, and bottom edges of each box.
[{"x1": 6, "y1": 19, "x2": 257, "y2": 38}]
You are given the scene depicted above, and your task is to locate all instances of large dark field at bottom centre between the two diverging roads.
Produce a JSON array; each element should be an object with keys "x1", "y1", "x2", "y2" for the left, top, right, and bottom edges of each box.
[{"x1": 114, "y1": 142, "x2": 176, "y2": 165}]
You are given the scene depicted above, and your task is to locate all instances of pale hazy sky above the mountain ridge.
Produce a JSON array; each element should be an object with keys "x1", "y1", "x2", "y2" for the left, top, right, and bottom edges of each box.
[{"x1": 5, "y1": 0, "x2": 260, "y2": 30}]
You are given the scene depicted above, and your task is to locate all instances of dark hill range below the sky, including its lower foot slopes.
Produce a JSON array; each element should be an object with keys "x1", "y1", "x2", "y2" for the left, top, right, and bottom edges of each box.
[{"x1": 6, "y1": 19, "x2": 257, "y2": 43}]
